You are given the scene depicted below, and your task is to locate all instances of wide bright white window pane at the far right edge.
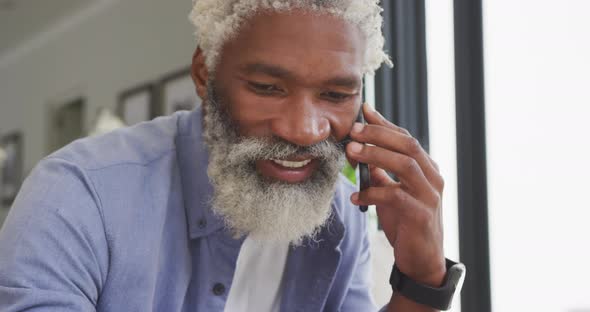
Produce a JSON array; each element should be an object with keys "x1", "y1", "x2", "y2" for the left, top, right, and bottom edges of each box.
[{"x1": 484, "y1": 0, "x2": 590, "y2": 312}]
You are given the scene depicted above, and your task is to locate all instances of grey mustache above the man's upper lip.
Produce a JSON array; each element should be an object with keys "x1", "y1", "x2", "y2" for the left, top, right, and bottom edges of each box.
[{"x1": 227, "y1": 137, "x2": 350, "y2": 163}]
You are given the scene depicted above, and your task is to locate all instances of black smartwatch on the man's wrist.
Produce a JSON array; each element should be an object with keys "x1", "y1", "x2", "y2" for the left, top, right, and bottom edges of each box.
[{"x1": 389, "y1": 259, "x2": 466, "y2": 311}]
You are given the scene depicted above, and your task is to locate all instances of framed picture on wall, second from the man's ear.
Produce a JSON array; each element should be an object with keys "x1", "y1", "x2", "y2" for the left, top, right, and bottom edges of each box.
[{"x1": 117, "y1": 83, "x2": 158, "y2": 126}]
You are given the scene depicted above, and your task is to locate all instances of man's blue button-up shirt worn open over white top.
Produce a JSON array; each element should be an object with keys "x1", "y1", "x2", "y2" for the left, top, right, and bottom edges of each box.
[{"x1": 0, "y1": 110, "x2": 384, "y2": 312}]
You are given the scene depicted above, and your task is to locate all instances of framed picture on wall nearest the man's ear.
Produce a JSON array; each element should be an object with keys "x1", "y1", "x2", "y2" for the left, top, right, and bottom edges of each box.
[{"x1": 159, "y1": 68, "x2": 201, "y2": 115}]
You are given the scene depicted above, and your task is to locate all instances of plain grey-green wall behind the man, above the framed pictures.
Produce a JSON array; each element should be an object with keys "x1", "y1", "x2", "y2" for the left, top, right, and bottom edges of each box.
[{"x1": 0, "y1": 0, "x2": 196, "y2": 180}]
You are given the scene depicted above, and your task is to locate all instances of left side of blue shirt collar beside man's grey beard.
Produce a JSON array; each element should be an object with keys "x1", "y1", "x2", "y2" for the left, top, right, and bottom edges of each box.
[{"x1": 176, "y1": 108, "x2": 223, "y2": 239}]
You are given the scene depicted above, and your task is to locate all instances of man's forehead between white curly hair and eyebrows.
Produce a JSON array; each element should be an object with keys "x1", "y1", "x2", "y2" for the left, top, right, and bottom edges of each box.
[{"x1": 218, "y1": 10, "x2": 365, "y2": 82}]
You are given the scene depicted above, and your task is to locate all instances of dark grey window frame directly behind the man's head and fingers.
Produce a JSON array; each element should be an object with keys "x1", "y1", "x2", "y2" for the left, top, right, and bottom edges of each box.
[{"x1": 375, "y1": 0, "x2": 429, "y2": 151}]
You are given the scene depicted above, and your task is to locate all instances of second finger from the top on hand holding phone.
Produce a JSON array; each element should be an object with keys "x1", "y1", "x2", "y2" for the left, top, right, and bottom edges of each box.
[{"x1": 350, "y1": 123, "x2": 444, "y2": 191}]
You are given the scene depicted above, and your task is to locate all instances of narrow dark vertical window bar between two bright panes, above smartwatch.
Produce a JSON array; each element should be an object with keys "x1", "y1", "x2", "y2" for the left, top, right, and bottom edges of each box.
[{"x1": 454, "y1": 0, "x2": 492, "y2": 312}]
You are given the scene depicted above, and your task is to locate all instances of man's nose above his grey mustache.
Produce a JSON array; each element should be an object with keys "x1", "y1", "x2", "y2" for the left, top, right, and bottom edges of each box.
[{"x1": 271, "y1": 96, "x2": 331, "y2": 146}]
